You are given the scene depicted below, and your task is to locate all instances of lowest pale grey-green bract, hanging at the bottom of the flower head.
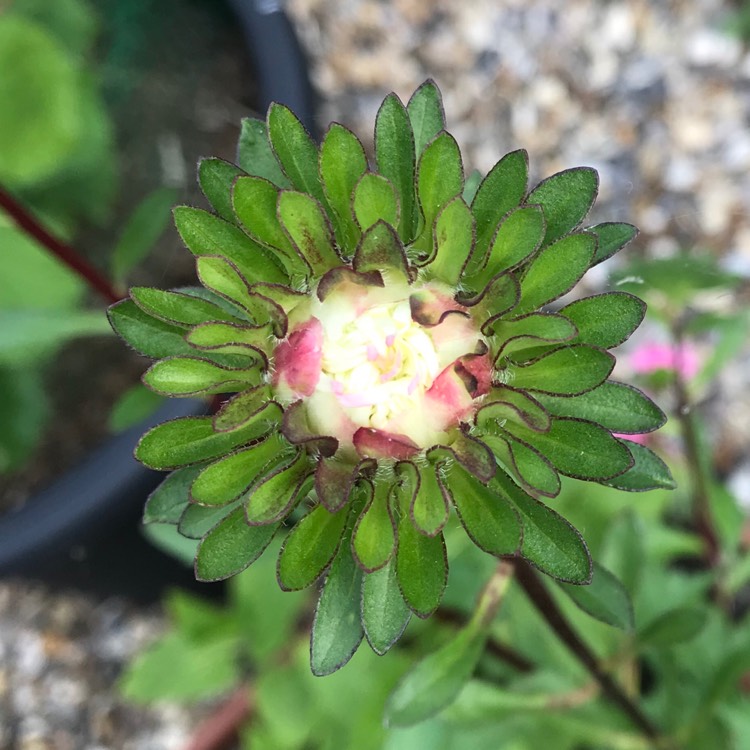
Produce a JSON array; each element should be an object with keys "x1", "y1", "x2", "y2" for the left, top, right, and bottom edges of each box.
[{"x1": 310, "y1": 538, "x2": 363, "y2": 677}]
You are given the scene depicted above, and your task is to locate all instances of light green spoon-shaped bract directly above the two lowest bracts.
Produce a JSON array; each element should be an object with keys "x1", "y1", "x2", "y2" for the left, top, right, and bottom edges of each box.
[{"x1": 352, "y1": 481, "x2": 396, "y2": 573}]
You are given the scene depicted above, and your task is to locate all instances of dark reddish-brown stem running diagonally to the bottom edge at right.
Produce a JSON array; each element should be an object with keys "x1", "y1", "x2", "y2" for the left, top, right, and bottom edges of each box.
[{"x1": 515, "y1": 560, "x2": 664, "y2": 747}]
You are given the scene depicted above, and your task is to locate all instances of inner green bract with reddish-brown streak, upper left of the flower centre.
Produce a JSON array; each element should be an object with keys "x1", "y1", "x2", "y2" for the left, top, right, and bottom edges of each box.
[{"x1": 278, "y1": 190, "x2": 341, "y2": 276}]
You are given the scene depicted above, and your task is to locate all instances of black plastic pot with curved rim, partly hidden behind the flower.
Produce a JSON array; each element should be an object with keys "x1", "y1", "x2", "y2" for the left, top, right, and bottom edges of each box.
[{"x1": 0, "y1": 0, "x2": 314, "y2": 601}]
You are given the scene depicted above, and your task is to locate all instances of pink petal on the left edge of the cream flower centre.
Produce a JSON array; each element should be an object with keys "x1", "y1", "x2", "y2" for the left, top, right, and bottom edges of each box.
[{"x1": 273, "y1": 318, "x2": 323, "y2": 396}]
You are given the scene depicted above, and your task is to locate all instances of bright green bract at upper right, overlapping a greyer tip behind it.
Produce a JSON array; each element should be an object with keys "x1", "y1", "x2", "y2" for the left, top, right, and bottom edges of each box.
[{"x1": 515, "y1": 234, "x2": 596, "y2": 314}]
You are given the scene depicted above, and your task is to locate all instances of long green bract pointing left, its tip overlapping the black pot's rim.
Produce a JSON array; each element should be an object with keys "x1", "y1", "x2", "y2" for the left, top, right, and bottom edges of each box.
[{"x1": 135, "y1": 403, "x2": 281, "y2": 471}]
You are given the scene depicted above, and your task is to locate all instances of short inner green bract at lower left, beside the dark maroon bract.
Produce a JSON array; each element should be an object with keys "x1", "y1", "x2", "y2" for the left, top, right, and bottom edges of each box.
[{"x1": 247, "y1": 450, "x2": 312, "y2": 526}]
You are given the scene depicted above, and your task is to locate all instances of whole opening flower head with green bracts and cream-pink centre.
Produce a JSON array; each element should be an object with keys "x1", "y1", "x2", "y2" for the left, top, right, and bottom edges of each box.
[{"x1": 110, "y1": 81, "x2": 672, "y2": 674}]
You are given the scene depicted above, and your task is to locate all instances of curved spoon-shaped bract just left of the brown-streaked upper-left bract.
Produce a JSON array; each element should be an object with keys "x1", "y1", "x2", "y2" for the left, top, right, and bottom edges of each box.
[{"x1": 232, "y1": 177, "x2": 309, "y2": 281}]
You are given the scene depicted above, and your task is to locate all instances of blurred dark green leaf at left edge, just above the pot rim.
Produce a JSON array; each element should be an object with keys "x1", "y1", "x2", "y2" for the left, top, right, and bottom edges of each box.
[{"x1": 0, "y1": 368, "x2": 49, "y2": 474}]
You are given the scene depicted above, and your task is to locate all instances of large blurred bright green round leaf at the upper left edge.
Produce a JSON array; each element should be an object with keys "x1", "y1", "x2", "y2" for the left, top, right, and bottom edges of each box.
[{"x1": 0, "y1": 13, "x2": 84, "y2": 187}]
